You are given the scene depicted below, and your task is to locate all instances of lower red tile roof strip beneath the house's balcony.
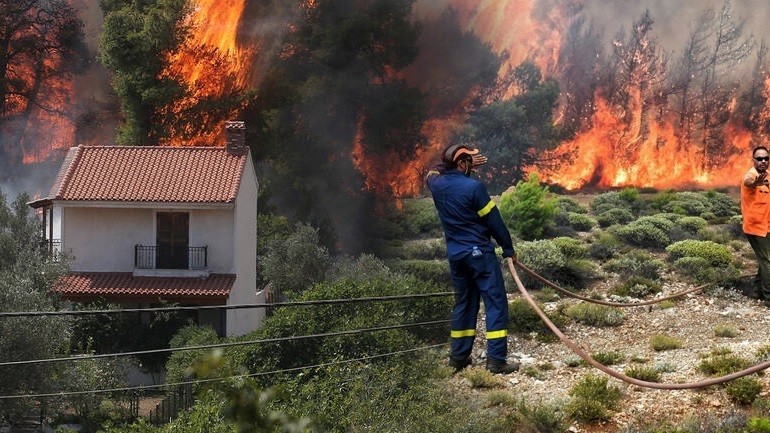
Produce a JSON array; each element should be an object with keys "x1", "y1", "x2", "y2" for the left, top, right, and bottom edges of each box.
[{"x1": 54, "y1": 272, "x2": 235, "y2": 304}]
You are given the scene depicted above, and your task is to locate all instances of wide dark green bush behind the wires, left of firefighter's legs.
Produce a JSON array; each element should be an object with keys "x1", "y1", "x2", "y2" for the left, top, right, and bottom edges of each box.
[{"x1": 240, "y1": 274, "x2": 452, "y2": 382}]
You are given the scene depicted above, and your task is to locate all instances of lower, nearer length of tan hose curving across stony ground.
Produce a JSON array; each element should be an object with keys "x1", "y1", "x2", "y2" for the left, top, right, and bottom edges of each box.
[{"x1": 506, "y1": 257, "x2": 770, "y2": 389}]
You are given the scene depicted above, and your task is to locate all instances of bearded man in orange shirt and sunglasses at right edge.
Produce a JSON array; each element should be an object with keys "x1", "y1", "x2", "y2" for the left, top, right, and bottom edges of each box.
[{"x1": 741, "y1": 146, "x2": 770, "y2": 300}]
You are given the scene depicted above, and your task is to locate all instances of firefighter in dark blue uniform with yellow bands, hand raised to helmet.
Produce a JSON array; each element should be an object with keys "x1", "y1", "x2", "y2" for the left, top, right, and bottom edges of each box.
[{"x1": 426, "y1": 144, "x2": 519, "y2": 374}]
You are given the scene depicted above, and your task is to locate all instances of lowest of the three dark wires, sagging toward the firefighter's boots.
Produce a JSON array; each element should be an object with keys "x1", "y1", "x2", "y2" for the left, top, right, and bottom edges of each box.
[{"x1": 0, "y1": 343, "x2": 449, "y2": 400}]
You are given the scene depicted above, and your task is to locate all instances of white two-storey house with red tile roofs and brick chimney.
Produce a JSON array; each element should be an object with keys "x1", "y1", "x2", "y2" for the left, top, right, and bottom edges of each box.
[{"x1": 29, "y1": 122, "x2": 264, "y2": 336}]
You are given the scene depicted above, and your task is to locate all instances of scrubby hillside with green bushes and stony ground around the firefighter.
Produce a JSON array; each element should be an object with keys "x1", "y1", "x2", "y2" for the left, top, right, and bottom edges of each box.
[{"x1": 58, "y1": 180, "x2": 770, "y2": 433}]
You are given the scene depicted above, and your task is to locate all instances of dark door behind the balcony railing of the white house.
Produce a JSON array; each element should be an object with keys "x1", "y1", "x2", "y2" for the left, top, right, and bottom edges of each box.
[{"x1": 155, "y1": 212, "x2": 190, "y2": 269}]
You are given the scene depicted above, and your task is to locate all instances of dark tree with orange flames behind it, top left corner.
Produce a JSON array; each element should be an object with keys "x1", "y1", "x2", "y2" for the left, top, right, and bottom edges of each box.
[{"x1": 0, "y1": 0, "x2": 86, "y2": 173}]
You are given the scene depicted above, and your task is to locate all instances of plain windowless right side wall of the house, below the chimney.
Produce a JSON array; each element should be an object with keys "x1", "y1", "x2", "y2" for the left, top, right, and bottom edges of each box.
[{"x1": 227, "y1": 155, "x2": 265, "y2": 336}]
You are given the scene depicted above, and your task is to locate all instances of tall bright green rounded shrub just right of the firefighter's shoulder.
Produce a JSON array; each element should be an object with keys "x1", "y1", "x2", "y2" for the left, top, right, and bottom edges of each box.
[{"x1": 500, "y1": 173, "x2": 558, "y2": 240}]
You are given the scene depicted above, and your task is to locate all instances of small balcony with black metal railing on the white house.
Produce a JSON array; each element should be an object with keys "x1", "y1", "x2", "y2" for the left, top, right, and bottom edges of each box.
[{"x1": 134, "y1": 245, "x2": 209, "y2": 277}]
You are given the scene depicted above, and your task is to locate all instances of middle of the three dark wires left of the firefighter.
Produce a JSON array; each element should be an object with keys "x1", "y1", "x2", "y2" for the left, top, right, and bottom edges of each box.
[{"x1": 0, "y1": 319, "x2": 450, "y2": 367}]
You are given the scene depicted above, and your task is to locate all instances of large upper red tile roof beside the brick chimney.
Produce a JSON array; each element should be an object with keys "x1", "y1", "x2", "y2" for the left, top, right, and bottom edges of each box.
[{"x1": 43, "y1": 146, "x2": 248, "y2": 203}]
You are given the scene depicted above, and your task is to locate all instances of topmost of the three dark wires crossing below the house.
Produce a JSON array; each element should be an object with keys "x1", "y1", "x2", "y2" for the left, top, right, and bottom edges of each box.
[{"x1": 0, "y1": 292, "x2": 454, "y2": 318}]
